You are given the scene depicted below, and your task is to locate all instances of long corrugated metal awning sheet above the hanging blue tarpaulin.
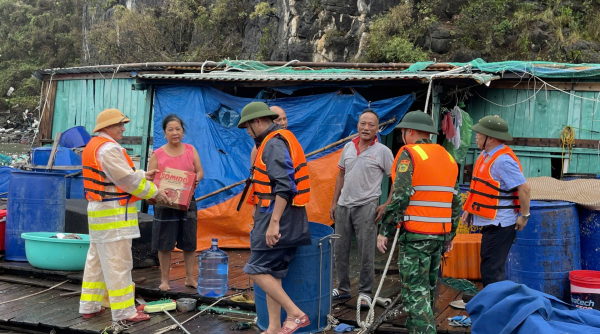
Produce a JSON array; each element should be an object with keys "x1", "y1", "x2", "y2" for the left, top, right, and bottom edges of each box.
[{"x1": 135, "y1": 71, "x2": 500, "y2": 84}]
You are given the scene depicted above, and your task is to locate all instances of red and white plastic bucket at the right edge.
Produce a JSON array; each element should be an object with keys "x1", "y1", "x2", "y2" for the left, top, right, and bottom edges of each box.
[{"x1": 569, "y1": 270, "x2": 600, "y2": 310}]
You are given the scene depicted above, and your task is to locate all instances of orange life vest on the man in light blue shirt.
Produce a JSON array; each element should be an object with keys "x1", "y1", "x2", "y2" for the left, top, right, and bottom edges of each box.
[{"x1": 463, "y1": 146, "x2": 523, "y2": 219}]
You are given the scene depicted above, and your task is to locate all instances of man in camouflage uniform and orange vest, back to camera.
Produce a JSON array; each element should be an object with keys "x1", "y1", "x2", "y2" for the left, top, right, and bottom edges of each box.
[{"x1": 377, "y1": 111, "x2": 461, "y2": 334}]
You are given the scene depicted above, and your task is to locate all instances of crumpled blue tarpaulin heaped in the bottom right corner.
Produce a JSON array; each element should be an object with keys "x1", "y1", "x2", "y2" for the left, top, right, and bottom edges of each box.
[{"x1": 466, "y1": 281, "x2": 600, "y2": 334}]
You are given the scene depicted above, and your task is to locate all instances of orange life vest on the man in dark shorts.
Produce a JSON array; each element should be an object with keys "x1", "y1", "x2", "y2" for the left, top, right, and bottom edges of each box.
[{"x1": 247, "y1": 130, "x2": 310, "y2": 207}]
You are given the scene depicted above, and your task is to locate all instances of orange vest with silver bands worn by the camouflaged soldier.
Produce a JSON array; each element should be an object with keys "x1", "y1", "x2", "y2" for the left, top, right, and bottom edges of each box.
[{"x1": 392, "y1": 144, "x2": 458, "y2": 234}]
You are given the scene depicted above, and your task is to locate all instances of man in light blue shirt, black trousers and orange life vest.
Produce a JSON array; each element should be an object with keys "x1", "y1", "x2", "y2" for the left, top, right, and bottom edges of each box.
[{"x1": 462, "y1": 116, "x2": 530, "y2": 287}]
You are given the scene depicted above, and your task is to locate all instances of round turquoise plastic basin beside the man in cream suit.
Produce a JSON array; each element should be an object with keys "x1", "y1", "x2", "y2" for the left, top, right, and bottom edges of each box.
[{"x1": 21, "y1": 232, "x2": 90, "y2": 270}]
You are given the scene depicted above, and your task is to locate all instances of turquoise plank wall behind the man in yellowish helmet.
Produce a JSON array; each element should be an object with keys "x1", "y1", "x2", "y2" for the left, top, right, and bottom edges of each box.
[{"x1": 52, "y1": 79, "x2": 154, "y2": 154}]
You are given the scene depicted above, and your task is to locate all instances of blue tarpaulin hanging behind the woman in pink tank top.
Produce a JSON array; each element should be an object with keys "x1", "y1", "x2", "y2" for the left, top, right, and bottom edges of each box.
[{"x1": 154, "y1": 86, "x2": 414, "y2": 209}]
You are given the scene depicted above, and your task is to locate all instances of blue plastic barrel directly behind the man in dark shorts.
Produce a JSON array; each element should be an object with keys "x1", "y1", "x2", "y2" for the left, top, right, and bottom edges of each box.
[{"x1": 254, "y1": 223, "x2": 333, "y2": 333}]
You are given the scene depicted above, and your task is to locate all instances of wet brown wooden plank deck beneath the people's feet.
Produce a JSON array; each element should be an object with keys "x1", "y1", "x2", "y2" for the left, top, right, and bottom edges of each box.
[{"x1": 0, "y1": 245, "x2": 481, "y2": 334}]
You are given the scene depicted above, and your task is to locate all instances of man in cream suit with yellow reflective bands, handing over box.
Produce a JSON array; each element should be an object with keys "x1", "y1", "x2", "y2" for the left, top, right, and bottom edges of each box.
[{"x1": 79, "y1": 109, "x2": 168, "y2": 322}]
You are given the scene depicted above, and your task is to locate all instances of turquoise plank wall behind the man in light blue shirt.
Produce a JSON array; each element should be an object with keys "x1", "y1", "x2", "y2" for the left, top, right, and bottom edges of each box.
[{"x1": 467, "y1": 89, "x2": 600, "y2": 177}]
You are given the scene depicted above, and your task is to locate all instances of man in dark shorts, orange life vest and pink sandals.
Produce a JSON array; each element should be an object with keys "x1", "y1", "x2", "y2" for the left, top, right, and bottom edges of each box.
[{"x1": 238, "y1": 102, "x2": 311, "y2": 334}]
